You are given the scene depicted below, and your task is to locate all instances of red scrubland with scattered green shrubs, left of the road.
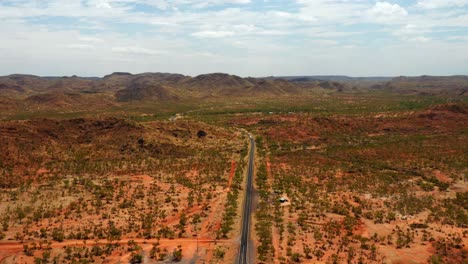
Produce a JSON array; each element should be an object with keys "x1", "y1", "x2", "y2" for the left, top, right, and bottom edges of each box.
[{"x1": 0, "y1": 120, "x2": 246, "y2": 263}]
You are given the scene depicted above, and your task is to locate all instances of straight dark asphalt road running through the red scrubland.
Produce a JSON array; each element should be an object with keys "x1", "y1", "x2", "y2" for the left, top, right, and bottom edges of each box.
[{"x1": 237, "y1": 134, "x2": 255, "y2": 264}]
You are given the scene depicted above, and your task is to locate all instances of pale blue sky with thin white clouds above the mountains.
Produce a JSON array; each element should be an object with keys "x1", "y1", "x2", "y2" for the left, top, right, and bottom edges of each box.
[{"x1": 0, "y1": 0, "x2": 468, "y2": 77}]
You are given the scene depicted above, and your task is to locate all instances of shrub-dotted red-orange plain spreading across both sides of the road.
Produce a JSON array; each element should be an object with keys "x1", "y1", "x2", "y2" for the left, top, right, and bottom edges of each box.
[{"x1": 0, "y1": 79, "x2": 468, "y2": 264}]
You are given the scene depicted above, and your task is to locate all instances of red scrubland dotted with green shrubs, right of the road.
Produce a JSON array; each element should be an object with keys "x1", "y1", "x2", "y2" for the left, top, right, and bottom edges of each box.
[{"x1": 240, "y1": 104, "x2": 468, "y2": 263}]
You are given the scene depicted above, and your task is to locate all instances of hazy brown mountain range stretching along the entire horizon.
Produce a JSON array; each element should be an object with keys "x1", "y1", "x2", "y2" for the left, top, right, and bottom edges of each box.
[{"x1": 0, "y1": 72, "x2": 468, "y2": 110}]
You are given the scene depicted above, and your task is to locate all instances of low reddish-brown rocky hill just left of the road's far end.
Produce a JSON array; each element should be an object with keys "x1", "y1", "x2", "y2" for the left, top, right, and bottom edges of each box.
[{"x1": 0, "y1": 117, "x2": 229, "y2": 179}]
